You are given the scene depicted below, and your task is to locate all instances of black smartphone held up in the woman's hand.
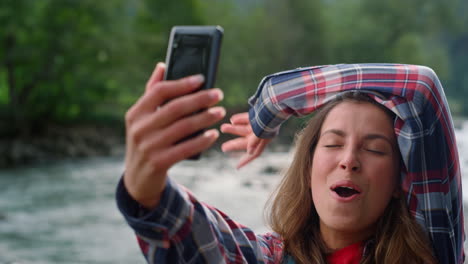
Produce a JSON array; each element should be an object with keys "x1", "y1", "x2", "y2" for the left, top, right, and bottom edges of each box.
[{"x1": 164, "y1": 26, "x2": 224, "y2": 160}]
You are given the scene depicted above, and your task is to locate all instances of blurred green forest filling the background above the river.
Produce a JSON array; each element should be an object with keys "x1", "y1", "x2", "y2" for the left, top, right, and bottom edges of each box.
[{"x1": 0, "y1": 0, "x2": 468, "y2": 163}]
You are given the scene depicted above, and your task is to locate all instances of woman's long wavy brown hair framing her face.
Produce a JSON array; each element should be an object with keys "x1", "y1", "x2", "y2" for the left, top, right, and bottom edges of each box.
[{"x1": 265, "y1": 92, "x2": 437, "y2": 264}]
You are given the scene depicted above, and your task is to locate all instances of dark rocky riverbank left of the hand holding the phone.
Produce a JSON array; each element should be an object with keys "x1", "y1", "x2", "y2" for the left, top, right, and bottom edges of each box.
[{"x1": 0, "y1": 124, "x2": 125, "y2": 168}]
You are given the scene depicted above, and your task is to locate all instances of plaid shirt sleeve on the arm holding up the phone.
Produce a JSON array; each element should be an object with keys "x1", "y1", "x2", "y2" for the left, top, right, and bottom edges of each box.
[{"x1": 116, "y1": 176, "x2": 282, "y2": 264}]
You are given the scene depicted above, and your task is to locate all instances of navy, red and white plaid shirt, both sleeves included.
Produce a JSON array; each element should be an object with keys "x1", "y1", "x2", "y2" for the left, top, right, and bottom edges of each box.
[{"x1": 117, "y1": 64, "x2": 464, "y2": 264}]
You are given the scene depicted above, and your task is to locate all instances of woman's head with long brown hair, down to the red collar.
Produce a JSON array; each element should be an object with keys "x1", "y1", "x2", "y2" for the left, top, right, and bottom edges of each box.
[{"x1": 260, "y1": 93, "x2": 436, "y2": 263}]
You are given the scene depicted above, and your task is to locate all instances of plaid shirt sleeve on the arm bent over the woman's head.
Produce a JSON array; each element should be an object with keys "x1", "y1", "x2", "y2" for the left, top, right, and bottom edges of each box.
[{"x1": 249, "y1": 64, "x2": 465, "y2": 264}]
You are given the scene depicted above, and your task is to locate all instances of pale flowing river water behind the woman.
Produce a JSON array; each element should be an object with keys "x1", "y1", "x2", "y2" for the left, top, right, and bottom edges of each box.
[{"x1": 0, "y1": 121, "x2": 468, "y2": 264}]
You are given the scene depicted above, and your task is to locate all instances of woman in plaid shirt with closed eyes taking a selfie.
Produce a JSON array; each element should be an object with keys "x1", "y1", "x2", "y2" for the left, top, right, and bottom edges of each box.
[{"x1": 117, "y1": 64, "x2": 463, "y2": 263}]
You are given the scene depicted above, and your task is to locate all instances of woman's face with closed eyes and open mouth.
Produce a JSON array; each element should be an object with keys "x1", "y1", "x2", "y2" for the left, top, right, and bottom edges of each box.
[{"x1": 311, "y1": 102, "x2": 399, "y2": 248}]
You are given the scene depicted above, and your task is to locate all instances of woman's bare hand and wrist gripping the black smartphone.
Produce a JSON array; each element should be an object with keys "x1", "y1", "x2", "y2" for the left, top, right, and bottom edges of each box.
[{"x1": 124, "y1": 63, "x2": 226, "y2": 209}]
